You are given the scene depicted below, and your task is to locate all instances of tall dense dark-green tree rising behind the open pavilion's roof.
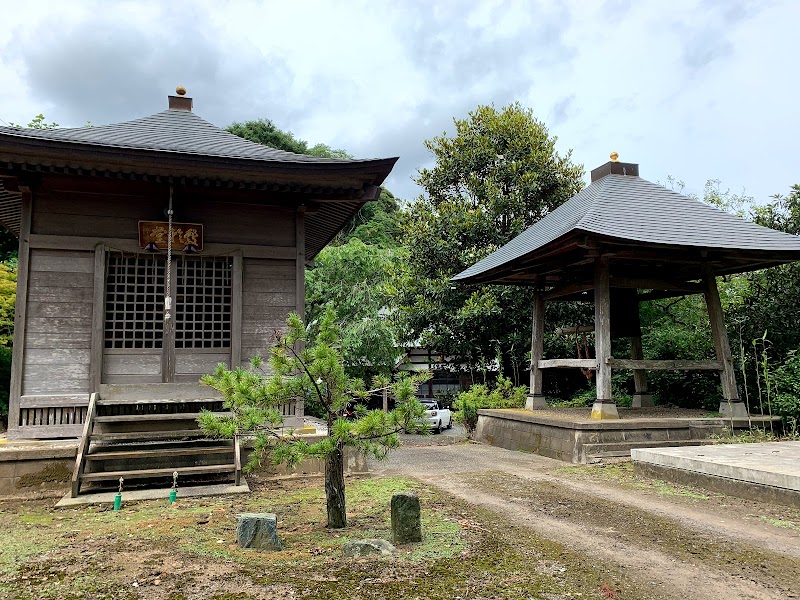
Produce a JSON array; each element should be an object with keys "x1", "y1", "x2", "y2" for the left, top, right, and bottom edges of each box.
[{"x1": 394, "y1": 103, "x2": 582, "y2": 382}]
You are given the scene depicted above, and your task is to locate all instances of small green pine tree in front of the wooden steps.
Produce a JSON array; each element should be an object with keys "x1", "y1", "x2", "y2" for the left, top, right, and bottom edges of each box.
[{"x1": 199, "y1": 310, "x2": 428, "y2": 528}]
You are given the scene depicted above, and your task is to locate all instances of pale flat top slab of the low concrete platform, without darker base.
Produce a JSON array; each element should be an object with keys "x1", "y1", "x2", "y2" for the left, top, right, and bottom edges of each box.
[{"x1": 631, "y1": 442, "x2": 800, "y2": 494}]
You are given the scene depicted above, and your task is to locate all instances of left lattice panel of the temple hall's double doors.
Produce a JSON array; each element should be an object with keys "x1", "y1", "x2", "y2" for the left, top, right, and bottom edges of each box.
[{"x1": 105, "y1": 252, "x2": 165, "y2": 348}]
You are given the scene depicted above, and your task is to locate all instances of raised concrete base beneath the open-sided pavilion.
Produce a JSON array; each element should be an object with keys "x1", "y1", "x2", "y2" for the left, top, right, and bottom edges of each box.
[{"x1": 475, "y1": 409, "x2": 780, "y2": 464}]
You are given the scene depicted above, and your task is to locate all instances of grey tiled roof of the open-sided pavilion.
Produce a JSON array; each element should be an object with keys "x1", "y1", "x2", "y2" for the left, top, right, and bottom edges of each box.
[{"x1": 453, "y1": 175, "x2": 800, "y2": 280}]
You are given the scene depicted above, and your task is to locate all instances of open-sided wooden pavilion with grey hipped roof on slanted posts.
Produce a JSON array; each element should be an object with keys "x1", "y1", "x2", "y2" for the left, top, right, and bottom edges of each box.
[{"x1": 454, "y1": 153, "x2": 800, "y2": 419}]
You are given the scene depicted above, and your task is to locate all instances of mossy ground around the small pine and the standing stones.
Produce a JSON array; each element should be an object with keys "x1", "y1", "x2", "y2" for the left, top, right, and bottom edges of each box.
[{"x1": 0, "y1": 478, "x2": 653, "y2": 600}]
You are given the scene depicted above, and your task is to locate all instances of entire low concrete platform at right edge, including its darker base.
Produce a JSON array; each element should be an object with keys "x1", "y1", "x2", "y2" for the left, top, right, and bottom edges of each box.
[{"x1": 631, "y1": 442, "x2": 800, "y2": 507}]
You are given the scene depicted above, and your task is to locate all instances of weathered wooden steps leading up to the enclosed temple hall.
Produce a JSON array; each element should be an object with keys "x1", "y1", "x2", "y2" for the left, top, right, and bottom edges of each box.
[{"x1": 72, "y1": 393, "x2": 241, "y2": 497}]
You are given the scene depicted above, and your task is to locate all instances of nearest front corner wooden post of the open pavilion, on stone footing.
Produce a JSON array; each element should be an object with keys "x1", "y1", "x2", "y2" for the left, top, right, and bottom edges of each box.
[{"x1": 591, "y1": 257, "x2": 619, "y2": 420}]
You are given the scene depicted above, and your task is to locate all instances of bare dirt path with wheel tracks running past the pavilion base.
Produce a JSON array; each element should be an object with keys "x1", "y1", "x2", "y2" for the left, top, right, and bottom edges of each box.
[{"x1": 375, "y1": 444, "x2": 800, "y2": 600}]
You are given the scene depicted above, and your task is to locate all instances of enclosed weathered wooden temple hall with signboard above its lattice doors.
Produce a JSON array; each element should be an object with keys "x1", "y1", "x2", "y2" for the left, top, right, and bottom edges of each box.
[{"x1": 0, "y1": 87, "x2": 397, "y2": 487}]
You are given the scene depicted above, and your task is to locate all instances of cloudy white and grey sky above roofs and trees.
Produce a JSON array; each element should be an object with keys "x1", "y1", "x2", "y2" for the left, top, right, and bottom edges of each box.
[{"x1": 0, "y1": 0, "x2": 800, "y2": 201}]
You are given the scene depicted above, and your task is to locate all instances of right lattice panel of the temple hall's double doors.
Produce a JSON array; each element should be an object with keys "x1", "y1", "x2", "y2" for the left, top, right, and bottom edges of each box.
[{"x1": 175, "y1": 256, "x2": 233, "y2": 348}]
